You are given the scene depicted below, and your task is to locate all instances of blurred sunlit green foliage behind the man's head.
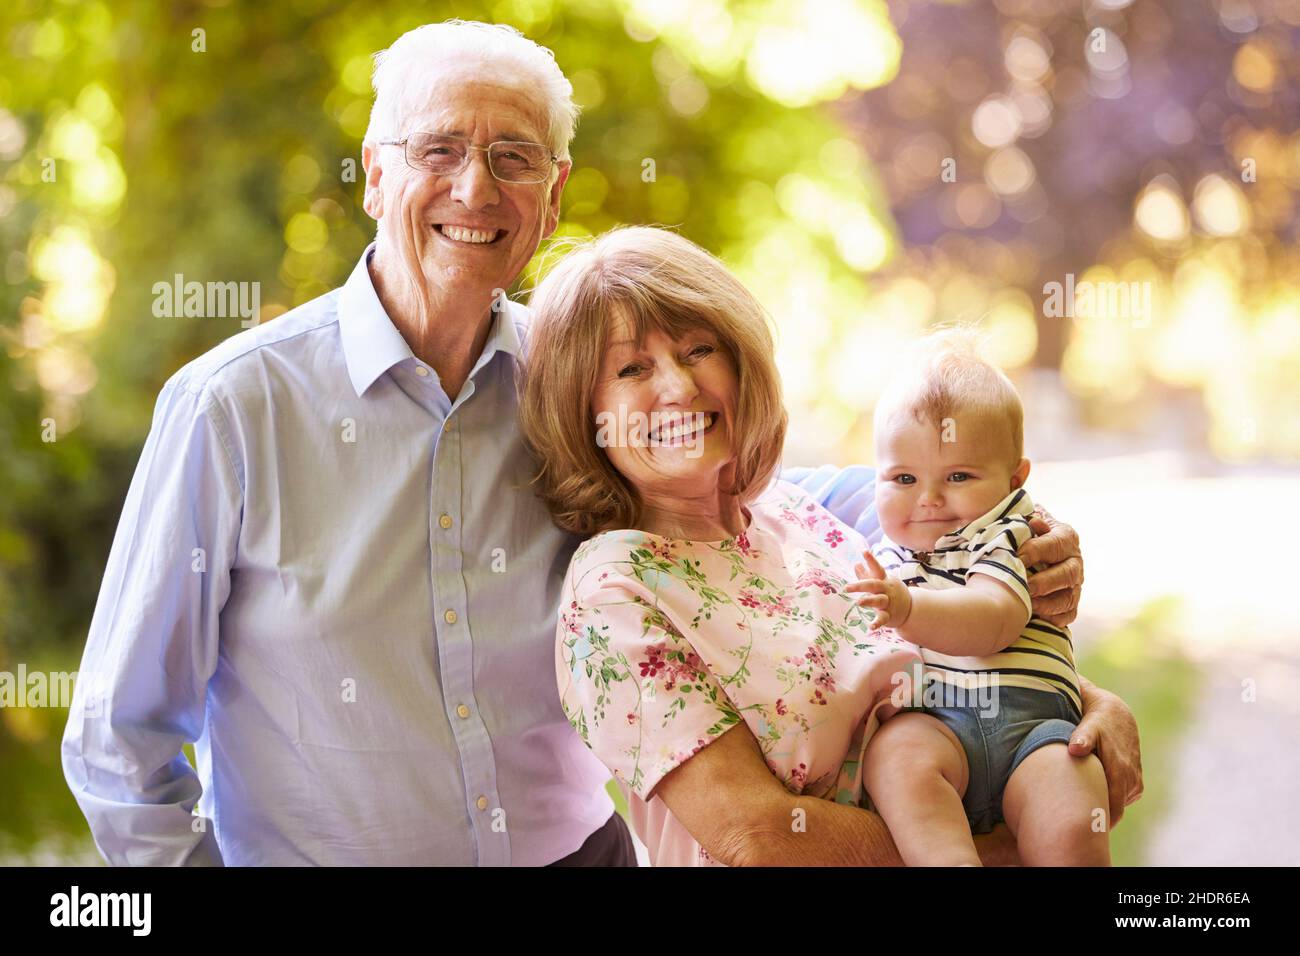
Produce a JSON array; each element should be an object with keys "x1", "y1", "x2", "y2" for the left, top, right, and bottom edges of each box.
[{"x1": 0, "y1": 0, "x2": 900, "y2": 665}]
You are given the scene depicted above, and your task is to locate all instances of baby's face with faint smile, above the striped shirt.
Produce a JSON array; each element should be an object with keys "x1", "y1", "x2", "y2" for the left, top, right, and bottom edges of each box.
[{"x1": 876, "y1": 412, "x2": 1030, "y2": 551}]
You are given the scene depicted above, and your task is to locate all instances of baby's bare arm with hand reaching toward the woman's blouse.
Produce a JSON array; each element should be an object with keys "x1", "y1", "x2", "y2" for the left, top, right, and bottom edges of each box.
[{"x1": 845, "y1": 551, "x2": 1030, "y2": 657}]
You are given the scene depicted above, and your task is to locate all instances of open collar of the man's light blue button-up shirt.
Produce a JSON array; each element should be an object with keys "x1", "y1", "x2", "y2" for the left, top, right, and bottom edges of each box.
[{"x1": 338, "y1": 242, "x2": 528, "y2": 395}]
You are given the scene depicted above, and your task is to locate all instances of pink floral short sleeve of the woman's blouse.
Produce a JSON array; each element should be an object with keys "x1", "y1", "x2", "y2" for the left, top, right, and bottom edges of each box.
[{"x1": 556, "y1": 572, "x2": 742, "y2": 800}]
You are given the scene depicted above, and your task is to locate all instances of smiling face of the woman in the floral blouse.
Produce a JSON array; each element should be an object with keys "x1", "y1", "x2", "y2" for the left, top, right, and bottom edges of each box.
[{"x1": 592, "y1": 316, "x2": 737, "y2": 501}]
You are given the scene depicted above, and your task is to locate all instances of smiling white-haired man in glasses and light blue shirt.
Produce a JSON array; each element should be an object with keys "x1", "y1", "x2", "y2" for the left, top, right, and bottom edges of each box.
[{"x1": 64, "y1": 21, "x2": 1139, "y2": 865}]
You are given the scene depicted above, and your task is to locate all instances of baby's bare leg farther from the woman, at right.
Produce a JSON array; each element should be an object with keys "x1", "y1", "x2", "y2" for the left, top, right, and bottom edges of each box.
[{"x1": 1002, "y1": 743, "x2": 1110, "y2": 866}]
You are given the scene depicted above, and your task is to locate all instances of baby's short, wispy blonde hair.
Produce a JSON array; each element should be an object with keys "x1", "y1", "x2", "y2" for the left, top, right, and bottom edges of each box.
[{"x1": 874, "y1": 326, "x2": 1024, "y2": 462}]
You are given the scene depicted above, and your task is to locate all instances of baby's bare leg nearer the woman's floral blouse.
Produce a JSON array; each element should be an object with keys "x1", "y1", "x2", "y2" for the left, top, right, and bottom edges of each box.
[{"x1": 862, "y1": 713, "x2": 980, "y2": 866}]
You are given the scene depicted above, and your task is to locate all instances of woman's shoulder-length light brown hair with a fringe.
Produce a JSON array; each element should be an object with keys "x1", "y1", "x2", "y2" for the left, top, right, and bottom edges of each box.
[{"x1": 519, "y1": 226, "x2": 787, "y2": 535}]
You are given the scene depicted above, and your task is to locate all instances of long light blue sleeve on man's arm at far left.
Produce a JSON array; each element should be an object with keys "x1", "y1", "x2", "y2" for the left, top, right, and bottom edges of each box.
[{"x1": 62, "y1": 377, "x2": 243, "y2": 865}]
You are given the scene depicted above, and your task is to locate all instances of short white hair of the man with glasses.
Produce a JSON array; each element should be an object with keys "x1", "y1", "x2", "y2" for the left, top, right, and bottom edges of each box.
[{"x1": 365, "y1": 20, "x2": 579, "y2": 160}]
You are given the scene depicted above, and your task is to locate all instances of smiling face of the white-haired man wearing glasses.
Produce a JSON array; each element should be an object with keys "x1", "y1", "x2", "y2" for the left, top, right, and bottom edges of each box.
[{"x1": 364, "y1": 62, "x2": 569, "y2": 297}]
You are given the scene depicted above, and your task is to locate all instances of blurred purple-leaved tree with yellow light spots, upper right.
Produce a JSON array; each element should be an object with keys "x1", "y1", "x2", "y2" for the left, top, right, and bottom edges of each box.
[{"x1": 840, "y1": 0, "x2": 1300, "y2": 459}]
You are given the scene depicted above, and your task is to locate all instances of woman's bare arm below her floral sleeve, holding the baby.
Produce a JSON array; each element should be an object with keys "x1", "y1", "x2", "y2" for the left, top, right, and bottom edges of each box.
[{"x1": 654, "y1": 723, "x2": 1018, "y2": 866}]
